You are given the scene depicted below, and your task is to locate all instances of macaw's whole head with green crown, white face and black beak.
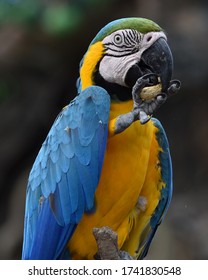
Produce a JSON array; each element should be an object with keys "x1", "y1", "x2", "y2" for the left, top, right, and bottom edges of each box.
[{"x1": 80, "y1": 18, "x2": 173, "y2": 100}]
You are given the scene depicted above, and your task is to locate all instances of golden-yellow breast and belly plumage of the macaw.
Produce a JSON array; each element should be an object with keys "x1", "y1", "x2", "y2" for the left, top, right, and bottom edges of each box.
[{"x1": 68, "y1": 99, "x2": 160, "y2": 259}]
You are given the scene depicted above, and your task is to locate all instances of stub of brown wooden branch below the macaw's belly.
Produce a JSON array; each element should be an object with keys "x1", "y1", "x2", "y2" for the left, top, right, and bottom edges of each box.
[{"x1": 93, "y1": 226, "x2": 133, "y2": 260}]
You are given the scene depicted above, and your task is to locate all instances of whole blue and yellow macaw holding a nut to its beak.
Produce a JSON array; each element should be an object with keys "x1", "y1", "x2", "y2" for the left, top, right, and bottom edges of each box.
[{"x1": 22, "y1": 18, "x2": 178, "y2": 259}]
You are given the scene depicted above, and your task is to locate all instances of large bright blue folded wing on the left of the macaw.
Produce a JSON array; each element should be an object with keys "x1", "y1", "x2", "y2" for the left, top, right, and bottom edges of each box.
[{"x1": 22, "y1": 86, "x2": 110, "y2": 259}]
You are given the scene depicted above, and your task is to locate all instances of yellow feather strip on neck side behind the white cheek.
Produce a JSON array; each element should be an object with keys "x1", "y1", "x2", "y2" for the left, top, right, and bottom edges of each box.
[{"x1": 80, "y1": 42, "x2": 104, "y2": 90}]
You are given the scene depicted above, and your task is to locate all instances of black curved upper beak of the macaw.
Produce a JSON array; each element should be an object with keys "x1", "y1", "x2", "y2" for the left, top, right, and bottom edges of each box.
[{"x1": 138, "y1": 38, "x2": 173, "y2": 92}]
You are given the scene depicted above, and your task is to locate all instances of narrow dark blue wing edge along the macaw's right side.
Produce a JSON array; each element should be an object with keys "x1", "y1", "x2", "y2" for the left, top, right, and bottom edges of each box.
[{"x1": 138, "y1": 118, "x2": 173, "y2": 259}]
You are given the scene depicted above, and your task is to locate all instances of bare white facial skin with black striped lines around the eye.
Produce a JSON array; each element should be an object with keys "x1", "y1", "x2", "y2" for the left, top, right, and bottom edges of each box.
[{"x1": 99, "y1": 29, "x2": 167, "y2": 86}]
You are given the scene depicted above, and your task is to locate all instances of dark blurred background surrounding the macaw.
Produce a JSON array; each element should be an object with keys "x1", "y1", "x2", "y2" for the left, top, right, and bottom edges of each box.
[{"x1": 0, "y1": 0, "x2": 208, "y2": 259}]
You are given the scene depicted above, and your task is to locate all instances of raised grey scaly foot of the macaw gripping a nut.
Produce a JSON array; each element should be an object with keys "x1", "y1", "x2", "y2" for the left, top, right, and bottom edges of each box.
[{"x1": 115, "y1": 73, "x2": 181, "y2": 134}]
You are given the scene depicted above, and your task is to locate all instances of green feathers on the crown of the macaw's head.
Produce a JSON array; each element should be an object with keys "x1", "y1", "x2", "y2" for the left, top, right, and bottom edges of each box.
[{"x1": 91, "y1": 18, "x2": 162, "y2": 45}]
